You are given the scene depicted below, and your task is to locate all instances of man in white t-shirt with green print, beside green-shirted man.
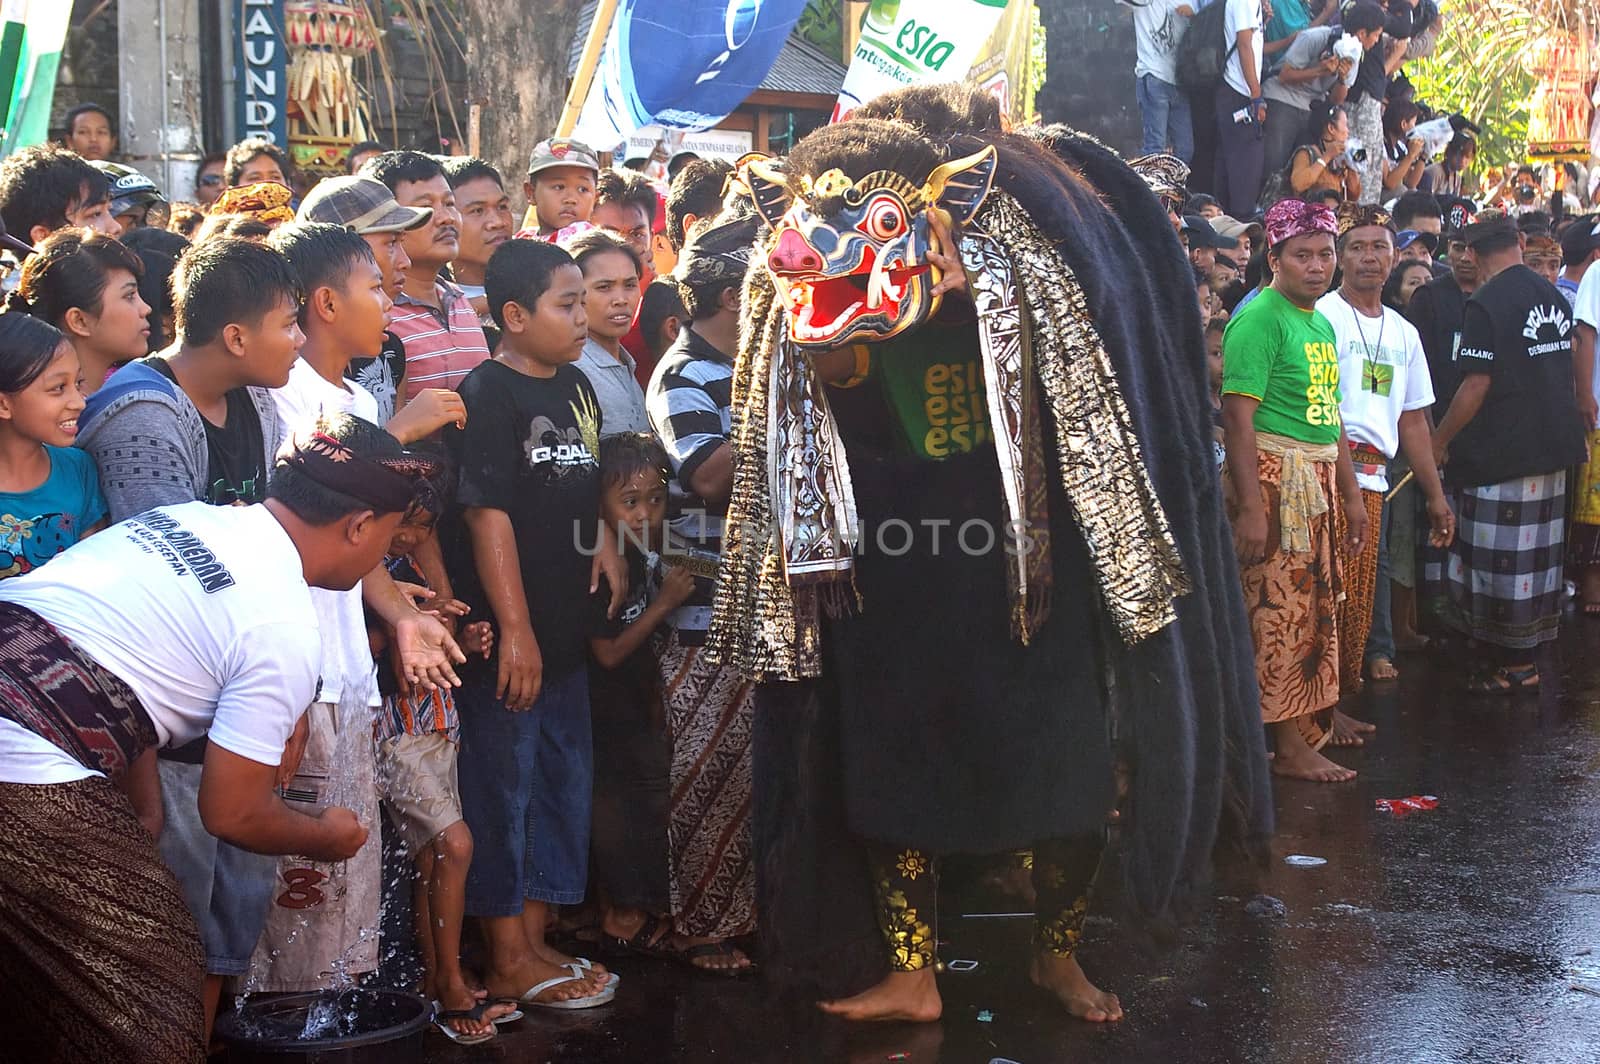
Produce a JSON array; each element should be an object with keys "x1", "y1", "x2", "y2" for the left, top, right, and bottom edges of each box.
[{"x1": 1317, "y1": 203, "x2": 1454, "y2": 729}]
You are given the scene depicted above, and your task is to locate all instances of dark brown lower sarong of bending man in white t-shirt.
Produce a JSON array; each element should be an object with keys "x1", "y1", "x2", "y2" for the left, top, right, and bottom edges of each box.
[{"x1": 0, "y1": 776, "x2": 205, "y2": 1064}]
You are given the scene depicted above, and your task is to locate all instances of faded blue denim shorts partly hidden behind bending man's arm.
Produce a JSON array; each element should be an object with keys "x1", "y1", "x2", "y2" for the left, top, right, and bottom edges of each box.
[{"x1": 157, "y1": 758, "x2": 278, "y2": 976}]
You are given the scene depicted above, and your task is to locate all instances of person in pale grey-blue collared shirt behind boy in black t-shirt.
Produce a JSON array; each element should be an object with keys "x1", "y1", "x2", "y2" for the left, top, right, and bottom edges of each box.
[{"x1": 566, "y1": 229, "x2": 650, "y2": 435}]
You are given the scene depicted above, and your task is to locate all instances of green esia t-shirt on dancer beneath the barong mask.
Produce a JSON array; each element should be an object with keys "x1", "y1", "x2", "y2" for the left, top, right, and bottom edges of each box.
[{"x1": 869, "y1": 322, "x2": 994, "y2": 461}]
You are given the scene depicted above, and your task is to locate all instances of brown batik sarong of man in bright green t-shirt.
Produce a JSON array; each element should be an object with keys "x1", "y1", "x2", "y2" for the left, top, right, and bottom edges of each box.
[{"x1": 1224, "y1": 451, "x2": 1360, "y2": 741}]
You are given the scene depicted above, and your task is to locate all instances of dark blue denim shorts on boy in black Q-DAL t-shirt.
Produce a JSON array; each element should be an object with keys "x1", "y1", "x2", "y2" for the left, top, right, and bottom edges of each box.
[{"x1": 456, "y1": 667, "x2": 594, "y2": 917}]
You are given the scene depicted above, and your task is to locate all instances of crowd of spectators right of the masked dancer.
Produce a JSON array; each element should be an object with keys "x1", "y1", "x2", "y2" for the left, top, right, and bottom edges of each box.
[{"x1": 1134, "y1": 0, "x2": 1600, "y2": 781}]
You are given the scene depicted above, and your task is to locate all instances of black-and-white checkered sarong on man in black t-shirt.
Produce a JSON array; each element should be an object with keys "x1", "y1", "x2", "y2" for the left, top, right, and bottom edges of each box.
[{"x1": 1427, "y1": 470, "x2": 1566, "y2": 650}]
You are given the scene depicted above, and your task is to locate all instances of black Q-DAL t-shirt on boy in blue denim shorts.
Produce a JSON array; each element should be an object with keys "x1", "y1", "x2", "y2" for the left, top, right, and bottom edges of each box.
[{"x1": 448, "y1": 360, "x2": 600, "y2": 682}]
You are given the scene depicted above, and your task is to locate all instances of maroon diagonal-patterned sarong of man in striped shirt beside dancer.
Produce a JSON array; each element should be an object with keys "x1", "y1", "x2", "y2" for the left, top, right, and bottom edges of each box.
[{"x1": 661, "y1": 632, "x2": 755, "y2": 938}]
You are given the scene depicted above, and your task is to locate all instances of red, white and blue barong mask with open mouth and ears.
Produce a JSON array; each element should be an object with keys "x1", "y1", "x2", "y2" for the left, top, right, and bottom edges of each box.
[{"x1": 742, "y1": 147, "x2": 997, "y2": 349}]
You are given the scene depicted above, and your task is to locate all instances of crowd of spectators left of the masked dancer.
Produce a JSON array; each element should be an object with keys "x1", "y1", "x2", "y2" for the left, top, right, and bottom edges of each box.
[{"x1": 0, "y1": 106, "x2": 768, "y2": 1059}]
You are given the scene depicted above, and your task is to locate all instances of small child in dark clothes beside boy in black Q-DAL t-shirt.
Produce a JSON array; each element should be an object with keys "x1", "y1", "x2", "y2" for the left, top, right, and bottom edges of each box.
[{"x1": 589, "y1": 432, "x2": 694, "y2": 957}]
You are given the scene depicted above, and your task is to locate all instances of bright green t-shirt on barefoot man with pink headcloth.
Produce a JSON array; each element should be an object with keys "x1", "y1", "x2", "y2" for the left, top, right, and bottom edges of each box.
[{"x1": 1222, "y1": 288, "x2": 1342, "y2": 443}]
